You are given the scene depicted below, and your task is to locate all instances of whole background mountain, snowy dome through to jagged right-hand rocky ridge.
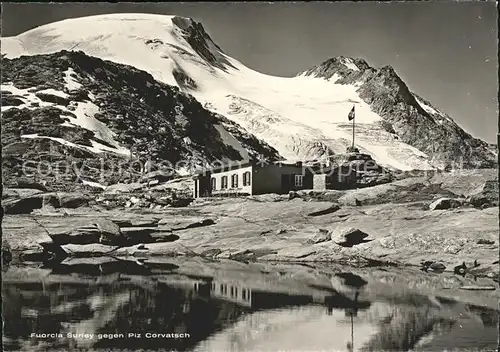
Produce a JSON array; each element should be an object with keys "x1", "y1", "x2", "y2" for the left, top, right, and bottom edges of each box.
[{"x1": 2, "y1": 14, "x2": 497, "y2": 170}]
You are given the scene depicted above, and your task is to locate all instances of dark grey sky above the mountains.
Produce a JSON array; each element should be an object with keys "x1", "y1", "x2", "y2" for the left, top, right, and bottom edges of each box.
[{"x1": 2, "y1": 1, "x2": 498, "y2": 142}]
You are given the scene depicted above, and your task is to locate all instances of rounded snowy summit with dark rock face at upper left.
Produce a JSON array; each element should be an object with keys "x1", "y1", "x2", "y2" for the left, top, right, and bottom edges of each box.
[{"x1": 2, "y1": 13, "x2": 236, "y2": 90}]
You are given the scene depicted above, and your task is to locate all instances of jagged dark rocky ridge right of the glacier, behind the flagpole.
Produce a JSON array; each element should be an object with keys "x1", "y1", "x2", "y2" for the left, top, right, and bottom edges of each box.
[{"x1": 301, "y1": 57, "x2": 497, "y2": 168}]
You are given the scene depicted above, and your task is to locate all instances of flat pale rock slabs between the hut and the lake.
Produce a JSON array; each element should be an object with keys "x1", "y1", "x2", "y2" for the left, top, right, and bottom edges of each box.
[{"x1": 2, "y1": 170, "x2": 499, "y2": 281}]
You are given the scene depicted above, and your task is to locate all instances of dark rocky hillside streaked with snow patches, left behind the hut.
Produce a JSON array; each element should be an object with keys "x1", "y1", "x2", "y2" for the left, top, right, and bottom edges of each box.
[{"x1": 2, "y1": 51, "x2": 280, "y2": 188}]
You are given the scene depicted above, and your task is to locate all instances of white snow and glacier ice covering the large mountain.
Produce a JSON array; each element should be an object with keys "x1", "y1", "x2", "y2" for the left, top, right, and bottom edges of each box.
[{"x1": 2, "y1": 13, "x2": 494, "y2": 170}]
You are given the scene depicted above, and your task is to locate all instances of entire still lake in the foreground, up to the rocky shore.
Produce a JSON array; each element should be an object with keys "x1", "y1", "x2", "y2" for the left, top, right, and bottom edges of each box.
[{"x1": 2, "y1": 258, "x2": 498, "y2": 352}]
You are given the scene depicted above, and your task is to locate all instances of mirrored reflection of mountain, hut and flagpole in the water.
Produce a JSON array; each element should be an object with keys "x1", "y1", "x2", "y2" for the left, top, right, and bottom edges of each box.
[{"x1": 3, "y1": 262, "x2": 498, "y2": 352}]
